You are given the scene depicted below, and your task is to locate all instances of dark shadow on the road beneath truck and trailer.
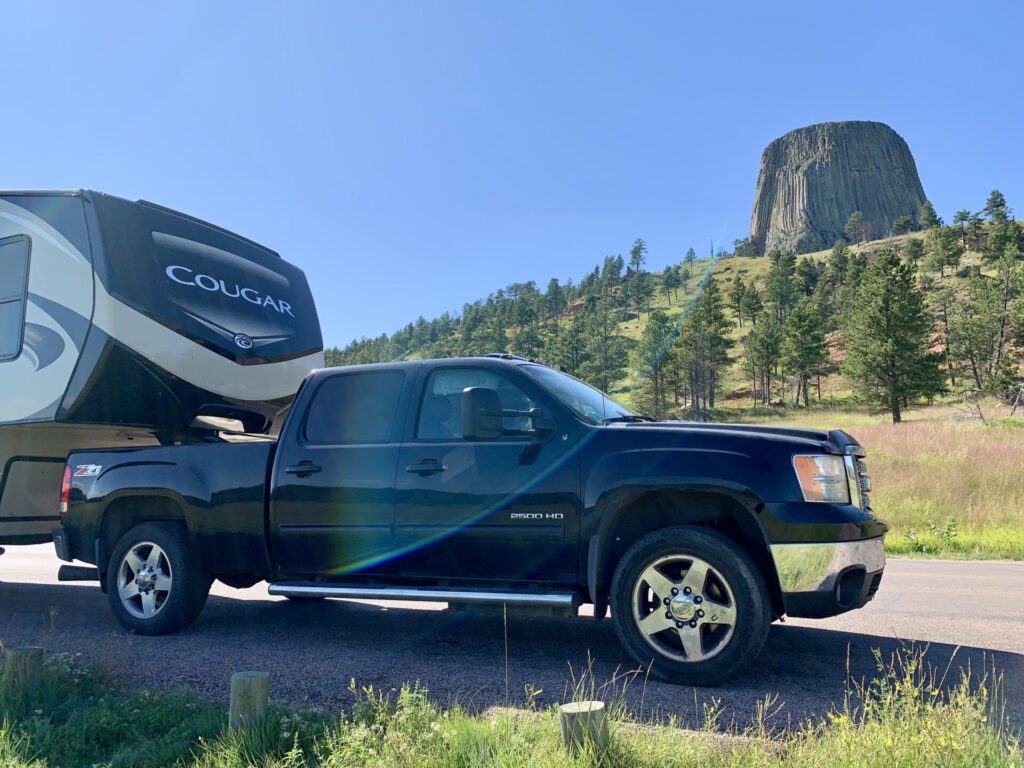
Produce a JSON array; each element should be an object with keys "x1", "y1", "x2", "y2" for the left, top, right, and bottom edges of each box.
[{"x1": 0, "y1": 583, "x2": 1024, "y2": 727}]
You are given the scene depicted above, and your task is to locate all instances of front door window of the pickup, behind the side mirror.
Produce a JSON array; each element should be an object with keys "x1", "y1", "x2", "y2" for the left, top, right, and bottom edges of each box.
[{"x1": 416, "y1": 368, "x2": 537, "y2": 440}]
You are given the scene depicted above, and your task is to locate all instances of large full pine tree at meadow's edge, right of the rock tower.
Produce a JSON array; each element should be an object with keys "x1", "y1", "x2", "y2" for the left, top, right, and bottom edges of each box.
[{"x1": 843, "y1": 251, "x2": 942, "y2": 424}]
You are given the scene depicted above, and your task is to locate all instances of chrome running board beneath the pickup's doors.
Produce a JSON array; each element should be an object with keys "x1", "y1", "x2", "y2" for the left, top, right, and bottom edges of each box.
[{"x1": 269, "y1": 582, "x2": 581, "y2": 610}]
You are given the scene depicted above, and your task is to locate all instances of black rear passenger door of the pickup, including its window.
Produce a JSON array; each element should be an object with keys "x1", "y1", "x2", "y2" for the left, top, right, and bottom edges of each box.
[{"x1": 270, "y1": 368, "x2": 415, "y2": 577}]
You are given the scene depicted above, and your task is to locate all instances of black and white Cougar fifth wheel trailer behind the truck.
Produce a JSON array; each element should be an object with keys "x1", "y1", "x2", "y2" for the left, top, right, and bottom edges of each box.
[{"x1": 0, "y1": 190, "x2": 324, "y2": 545}]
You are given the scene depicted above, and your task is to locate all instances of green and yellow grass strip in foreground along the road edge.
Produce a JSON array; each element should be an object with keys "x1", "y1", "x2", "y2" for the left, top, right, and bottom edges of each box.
[{"x1": 0, "y1": 654, "x2": 1022, "y2": 768}]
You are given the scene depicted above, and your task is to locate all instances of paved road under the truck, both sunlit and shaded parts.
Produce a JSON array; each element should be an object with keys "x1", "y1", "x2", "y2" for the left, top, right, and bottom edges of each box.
[{"x1": 0, "y1": 547, "x2": 1024, "y2": 726}]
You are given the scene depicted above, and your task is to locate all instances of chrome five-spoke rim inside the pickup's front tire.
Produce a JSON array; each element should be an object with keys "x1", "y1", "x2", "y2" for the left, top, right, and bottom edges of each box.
[{"x1": 633, "y1": 555, "x2": 736, "y2": 663}]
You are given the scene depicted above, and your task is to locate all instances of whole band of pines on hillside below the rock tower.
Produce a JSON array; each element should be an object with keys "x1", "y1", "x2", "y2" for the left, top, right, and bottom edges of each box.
[{"x1": 327, "y1": 190, "x2": 1024, "y2": 422}]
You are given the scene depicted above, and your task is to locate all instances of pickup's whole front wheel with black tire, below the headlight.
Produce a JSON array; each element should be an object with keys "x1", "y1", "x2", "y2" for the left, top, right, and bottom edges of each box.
[{"x1": 610, "y1": 525, "x2": 772, "y2": 685}]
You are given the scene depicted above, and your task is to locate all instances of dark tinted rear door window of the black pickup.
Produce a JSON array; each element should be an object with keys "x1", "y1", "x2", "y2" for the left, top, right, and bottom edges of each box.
[{"x1": 305, "y1": 371, "x2": 406, "y2": 445}]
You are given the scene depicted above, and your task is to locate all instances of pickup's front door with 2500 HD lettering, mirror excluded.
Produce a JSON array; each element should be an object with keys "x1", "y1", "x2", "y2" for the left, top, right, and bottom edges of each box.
[{"x1": 393, "y1": 367, "x2": 580, "y2": 584}]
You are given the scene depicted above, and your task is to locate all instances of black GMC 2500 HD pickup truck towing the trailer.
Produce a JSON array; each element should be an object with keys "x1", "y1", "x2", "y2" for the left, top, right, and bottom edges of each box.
[{"x1": 54, "y1": 355, "x2": 886, "y2": 684}]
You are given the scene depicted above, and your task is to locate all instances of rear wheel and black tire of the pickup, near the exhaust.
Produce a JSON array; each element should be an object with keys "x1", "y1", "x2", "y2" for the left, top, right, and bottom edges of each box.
[{"x1": 105, "y1": 522, "x2": 213, "y2": 635}]
